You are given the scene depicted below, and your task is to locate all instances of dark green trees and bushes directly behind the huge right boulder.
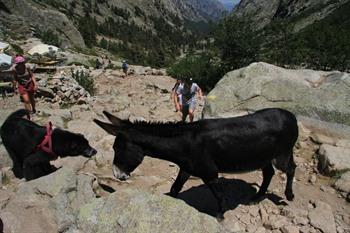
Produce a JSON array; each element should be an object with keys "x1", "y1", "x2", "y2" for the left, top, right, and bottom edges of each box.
[{"x1": 169, "y1": 3, "x2": 350, "y2": 89}]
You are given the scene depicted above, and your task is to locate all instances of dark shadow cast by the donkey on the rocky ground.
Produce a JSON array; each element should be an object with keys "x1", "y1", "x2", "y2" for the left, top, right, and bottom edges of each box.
[{"x1": 178, "y1": 178, "x2": 286, "y2": 217}]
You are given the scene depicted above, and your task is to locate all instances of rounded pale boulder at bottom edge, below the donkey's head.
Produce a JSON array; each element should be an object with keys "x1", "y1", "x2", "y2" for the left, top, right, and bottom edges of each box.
[{"x1": 78, "y1": 189, "x2": 224, "y2": 233}]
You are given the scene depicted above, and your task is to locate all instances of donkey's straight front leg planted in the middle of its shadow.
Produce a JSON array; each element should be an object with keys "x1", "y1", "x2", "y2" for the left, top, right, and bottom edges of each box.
[{"x1": 203, "y1": 177, "x2": 227, "y2": 221}]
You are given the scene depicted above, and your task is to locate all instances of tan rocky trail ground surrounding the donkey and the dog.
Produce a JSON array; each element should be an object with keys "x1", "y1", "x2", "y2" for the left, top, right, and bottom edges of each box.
[{"x1": 0, "y1": 66, "x2": 350, "y2": 233}]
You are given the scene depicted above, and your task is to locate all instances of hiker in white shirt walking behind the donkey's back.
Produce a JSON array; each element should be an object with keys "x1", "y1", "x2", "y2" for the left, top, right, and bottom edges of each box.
[{"x1": 179, "y1": 78, "x2": 203, "y2": 122}]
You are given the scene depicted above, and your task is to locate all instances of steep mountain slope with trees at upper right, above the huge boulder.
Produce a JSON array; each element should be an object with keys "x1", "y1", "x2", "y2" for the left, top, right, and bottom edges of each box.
[{"x1": 216, "y1": 0, "x2": 350, "y2": 72}]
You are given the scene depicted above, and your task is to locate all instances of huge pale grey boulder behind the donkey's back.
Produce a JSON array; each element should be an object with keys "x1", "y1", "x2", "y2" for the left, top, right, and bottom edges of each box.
[{"x1": 203, "y1": 62, "x2": 350, "y2": 135}]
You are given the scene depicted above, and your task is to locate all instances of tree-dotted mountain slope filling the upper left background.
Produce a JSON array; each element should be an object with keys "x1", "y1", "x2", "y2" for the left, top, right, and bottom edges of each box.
[{"x1": 0, "y1": 0, "x2": 225, "y2": 66}]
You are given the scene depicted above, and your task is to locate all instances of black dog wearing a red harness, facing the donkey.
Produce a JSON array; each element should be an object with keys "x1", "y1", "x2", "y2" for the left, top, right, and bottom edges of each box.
[{"x1": 0, "y1": 109, "x2": 97, "y2": 180}]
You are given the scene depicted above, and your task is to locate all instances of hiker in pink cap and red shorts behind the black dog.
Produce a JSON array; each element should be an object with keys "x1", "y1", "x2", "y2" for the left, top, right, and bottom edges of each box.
[{"x1": 12, "y1": 55, "x2": 38, "y2": 118}]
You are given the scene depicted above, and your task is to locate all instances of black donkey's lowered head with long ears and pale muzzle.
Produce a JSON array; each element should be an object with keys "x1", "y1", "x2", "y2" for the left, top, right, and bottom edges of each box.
[{"x1": 94, "y1": 111, "x2": 144, "y2": 180}]
